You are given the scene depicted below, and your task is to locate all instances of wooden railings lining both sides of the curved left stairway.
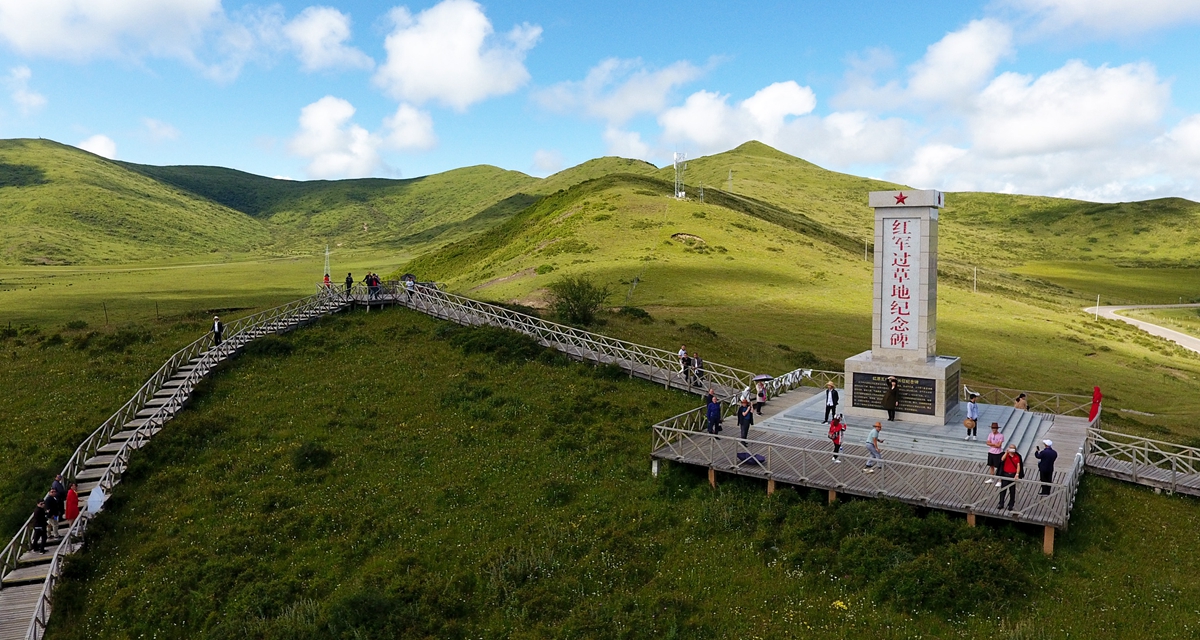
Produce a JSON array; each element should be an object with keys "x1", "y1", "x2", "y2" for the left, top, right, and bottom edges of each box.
[{"x1": 0, "y1": 291, "x2": 344, "y2": 640}]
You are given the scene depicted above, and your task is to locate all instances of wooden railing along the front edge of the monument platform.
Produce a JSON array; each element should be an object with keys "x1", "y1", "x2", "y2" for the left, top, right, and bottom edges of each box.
[{"x1": 653, "y1": 417, "x2": 1082, "y2": 528}]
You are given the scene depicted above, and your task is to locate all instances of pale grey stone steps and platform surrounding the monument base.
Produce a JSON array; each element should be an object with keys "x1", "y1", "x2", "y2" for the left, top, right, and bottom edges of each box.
[{"x1": 754, "y1": 391, "x2": 1051, "y2": 461}]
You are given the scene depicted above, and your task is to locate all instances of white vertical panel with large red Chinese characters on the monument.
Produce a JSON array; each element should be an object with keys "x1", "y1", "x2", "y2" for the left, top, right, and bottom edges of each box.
[{"x1": 880, "y1": 217, "x2": 920, "y2": 349}]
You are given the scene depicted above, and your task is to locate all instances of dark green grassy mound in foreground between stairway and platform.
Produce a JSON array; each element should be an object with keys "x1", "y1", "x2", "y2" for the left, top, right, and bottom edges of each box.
[{"x1": 52, "y1": 310, "x2": 1070, "y2": 638}]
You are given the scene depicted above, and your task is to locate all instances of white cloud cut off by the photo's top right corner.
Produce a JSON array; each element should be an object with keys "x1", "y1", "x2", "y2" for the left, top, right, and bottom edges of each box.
[{"x1": 1003, "y1": 0, "x2": 1200, "y2": 35}]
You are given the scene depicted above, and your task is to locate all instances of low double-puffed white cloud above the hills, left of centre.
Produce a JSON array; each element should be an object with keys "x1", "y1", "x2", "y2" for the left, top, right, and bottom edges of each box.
[{"x1": 288, "y1": 96, "x2": 437, "y2": 179}]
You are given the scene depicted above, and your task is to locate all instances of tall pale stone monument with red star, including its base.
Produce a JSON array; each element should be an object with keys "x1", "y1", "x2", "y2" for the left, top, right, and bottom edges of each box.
[{"x1": 844, "y1": 191, "x2": 959, "y2": 425}]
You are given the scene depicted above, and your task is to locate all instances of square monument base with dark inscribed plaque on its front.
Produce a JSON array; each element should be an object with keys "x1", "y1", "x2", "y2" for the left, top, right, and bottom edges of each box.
[{"x1": 842, "y1": 351, "x2": 960, "y2": 425}]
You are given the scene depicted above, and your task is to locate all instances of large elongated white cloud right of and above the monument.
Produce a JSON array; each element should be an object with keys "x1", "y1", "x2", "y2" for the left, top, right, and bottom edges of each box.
[{"x1": 970, "y1": 60, "x2": 1170, "y2": 156}]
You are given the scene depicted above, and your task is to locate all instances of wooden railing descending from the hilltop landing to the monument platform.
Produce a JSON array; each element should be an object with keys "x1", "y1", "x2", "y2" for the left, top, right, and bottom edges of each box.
[{"x1": 374, "y1": 285, "x2": 754, "y2": 399}]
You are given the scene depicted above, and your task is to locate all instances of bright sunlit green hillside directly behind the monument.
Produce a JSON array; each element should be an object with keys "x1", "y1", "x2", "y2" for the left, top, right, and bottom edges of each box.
[{"x1": 404, "y1": 146, "x2": 1200, "y2": 437}]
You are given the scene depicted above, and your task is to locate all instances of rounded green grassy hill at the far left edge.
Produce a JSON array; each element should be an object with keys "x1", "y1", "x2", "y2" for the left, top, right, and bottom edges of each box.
[{"x1": 0, "y1": 140, "x2": 270, "y2": 264}]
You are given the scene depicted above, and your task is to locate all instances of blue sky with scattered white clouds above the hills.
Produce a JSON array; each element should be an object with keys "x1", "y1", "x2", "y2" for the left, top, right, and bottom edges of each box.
[{"x1": 0, "y1": 0, "x2": 1200, "y2": 201}]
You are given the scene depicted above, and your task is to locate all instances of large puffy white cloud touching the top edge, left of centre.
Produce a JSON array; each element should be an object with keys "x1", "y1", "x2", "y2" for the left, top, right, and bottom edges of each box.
[{"x1": 374, "y1": 0, "x2": 541, "y2": 112}]
